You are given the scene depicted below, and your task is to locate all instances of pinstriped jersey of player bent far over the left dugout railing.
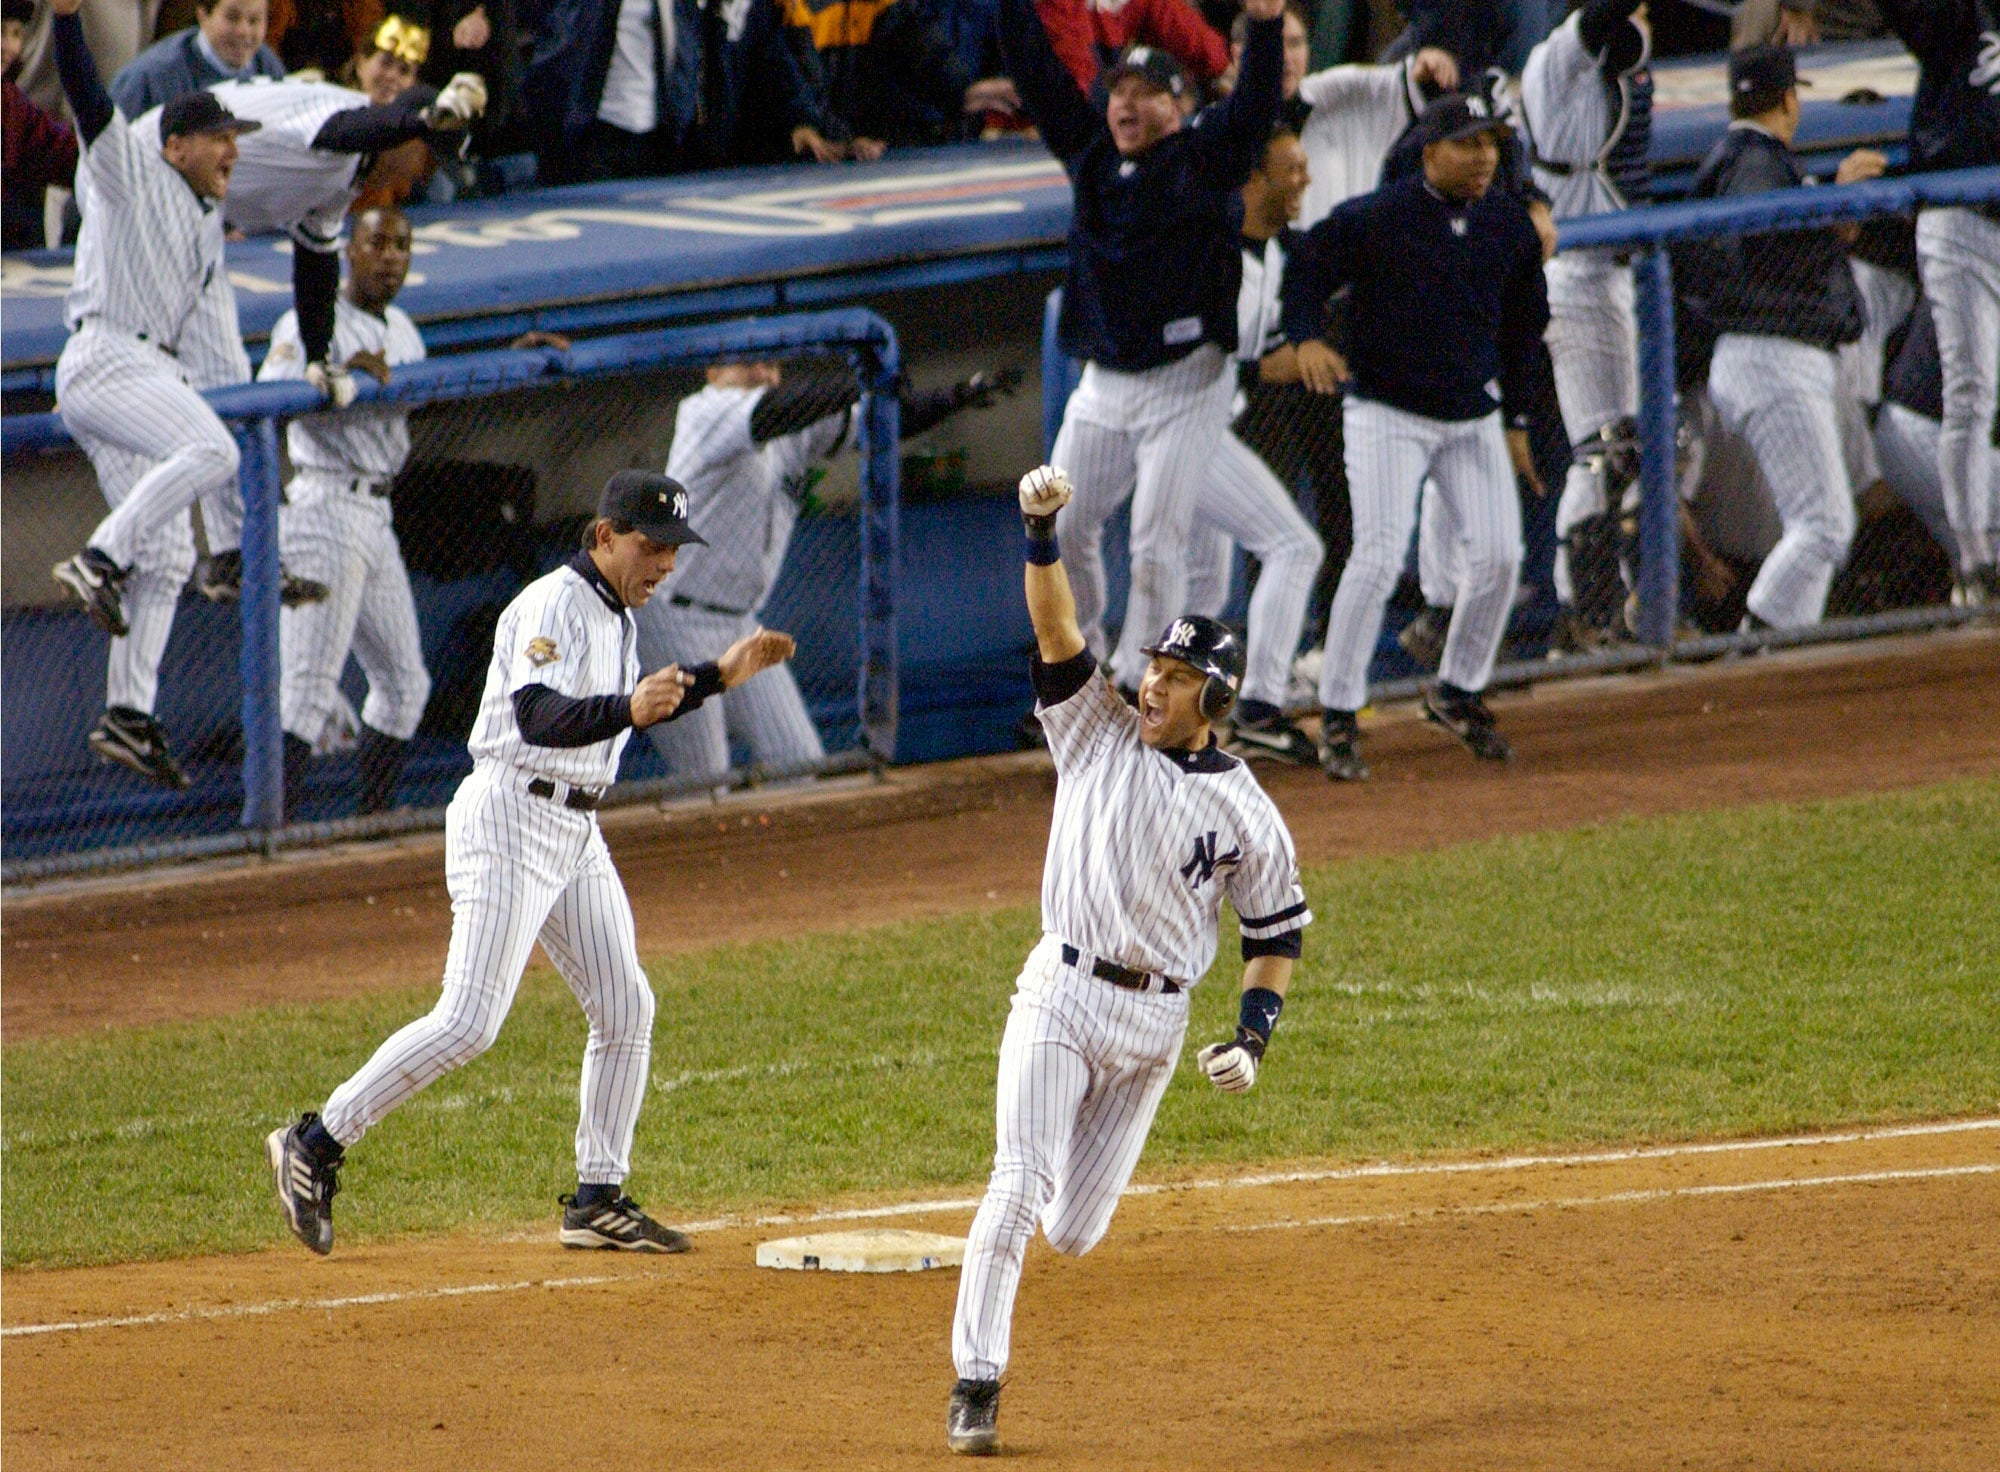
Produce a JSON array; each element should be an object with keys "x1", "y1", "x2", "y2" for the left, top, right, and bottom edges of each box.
[{"x1": 205, "y1": 76, "x2": 368, "y2": 250}]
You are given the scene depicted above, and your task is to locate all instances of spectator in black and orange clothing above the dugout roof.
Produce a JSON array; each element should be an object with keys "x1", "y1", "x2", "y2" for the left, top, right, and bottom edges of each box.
[{"x1": 784, "y1": 0, "x2": 1020, "y2": 160}]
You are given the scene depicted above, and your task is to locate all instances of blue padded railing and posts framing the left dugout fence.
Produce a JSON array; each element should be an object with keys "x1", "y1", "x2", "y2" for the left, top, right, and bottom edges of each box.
[{"x1": 0, "y1": 308, "x2": 902, "y2": 858}]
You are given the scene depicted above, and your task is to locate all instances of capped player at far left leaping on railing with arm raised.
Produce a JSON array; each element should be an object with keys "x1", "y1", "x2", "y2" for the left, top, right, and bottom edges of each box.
[{"x1": 52, "y1": 0, "x2": 258, "y2": 788}]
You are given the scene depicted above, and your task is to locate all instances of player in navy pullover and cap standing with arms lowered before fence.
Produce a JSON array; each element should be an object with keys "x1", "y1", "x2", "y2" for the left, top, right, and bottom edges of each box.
[{"x1": 1284, "y1": 94, "x2": 1548, "y2": 782}]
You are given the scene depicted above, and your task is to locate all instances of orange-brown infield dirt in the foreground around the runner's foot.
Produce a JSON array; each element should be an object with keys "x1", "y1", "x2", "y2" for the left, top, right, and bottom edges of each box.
[{"x1": 0, "y1": 1120, "x2": 2000, "y2": 1472}]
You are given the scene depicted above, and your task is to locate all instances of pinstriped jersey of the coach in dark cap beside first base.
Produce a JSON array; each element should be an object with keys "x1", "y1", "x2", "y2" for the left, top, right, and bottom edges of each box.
[{"x1": 466, "y1": 566, "x2": 638, "y2": 788}]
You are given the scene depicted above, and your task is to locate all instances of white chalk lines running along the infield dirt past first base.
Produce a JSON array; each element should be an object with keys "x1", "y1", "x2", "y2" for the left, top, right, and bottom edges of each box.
[{"x1": 0, "y1": 1118, "x2": 2000, "y2": 1338}]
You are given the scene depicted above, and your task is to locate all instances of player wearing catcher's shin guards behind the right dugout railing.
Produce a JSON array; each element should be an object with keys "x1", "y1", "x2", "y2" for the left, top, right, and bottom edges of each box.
[{"x1": 1520, "y1": 0, "x2": 1652, "y2": 652}]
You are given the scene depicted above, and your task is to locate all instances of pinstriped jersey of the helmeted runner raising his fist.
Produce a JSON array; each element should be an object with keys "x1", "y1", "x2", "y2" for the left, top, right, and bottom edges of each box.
[{"x1": 1036, "y1": 672, "x2": 1312, "y2": 984}]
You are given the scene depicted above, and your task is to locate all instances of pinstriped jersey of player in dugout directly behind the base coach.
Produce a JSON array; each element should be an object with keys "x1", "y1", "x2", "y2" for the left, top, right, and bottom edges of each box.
[{"x1": 660, "y1": 386, "x2": 856, "y2": 614}]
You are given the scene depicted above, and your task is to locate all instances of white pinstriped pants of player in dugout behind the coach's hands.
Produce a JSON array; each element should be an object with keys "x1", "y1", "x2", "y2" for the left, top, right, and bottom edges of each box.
[{"x1": 636, "y1": 594, "x2": 826, "y2": 782}]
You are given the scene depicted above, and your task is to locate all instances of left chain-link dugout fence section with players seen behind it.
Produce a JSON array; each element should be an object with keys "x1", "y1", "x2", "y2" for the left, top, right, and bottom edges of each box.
[{"x1": 0, "y1": 312, "x2": 898, "y2": 882}]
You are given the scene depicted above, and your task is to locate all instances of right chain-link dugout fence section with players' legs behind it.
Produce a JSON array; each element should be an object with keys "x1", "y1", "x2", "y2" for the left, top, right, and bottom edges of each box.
[{"x1": 1042, "y1": 168, "x2": 2000, "y2": 710}]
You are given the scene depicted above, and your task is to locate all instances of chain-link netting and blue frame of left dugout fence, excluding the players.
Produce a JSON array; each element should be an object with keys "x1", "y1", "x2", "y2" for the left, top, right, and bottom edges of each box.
[{"x1": 0, "y1": 310, "x2": 900, "y2": 882}]
